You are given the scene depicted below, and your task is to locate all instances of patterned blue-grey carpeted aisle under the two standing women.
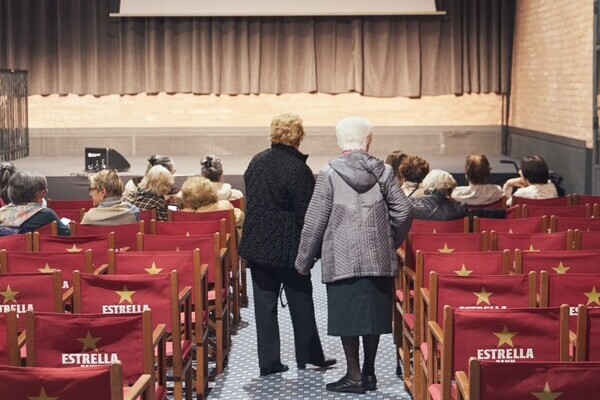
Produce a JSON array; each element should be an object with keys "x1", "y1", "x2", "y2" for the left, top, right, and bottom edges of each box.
[{"x1": 208, "y1": 267, "x2": 410, "y2": 400}]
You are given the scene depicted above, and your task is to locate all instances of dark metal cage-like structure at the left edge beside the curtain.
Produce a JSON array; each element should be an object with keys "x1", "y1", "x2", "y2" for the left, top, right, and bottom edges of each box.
[{"x1": 0, "y1": 69, "x2": 29, "y2": 161}]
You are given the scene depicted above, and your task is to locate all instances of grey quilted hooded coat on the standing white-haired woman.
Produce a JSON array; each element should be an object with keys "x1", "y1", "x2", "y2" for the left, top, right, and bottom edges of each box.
[{"x1": 296, "y1": 151, "x2": 412, "y2": 283}]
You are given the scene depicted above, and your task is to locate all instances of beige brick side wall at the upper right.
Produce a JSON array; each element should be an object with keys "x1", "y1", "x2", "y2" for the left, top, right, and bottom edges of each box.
[{"x1": 510, "y1": 0, "x2": 594, "y2": 147}]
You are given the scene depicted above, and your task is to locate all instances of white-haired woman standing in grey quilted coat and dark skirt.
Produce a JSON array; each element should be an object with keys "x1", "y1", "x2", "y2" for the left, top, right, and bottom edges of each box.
[{"x1": 296, "y1": 117, "x2": 412, "y2": 393}]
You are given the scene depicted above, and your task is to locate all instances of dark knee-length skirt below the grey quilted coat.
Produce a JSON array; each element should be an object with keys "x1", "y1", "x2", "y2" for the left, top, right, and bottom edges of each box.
[{"x1": 327, "y1": 276, "x2": 394, "y2": 336}]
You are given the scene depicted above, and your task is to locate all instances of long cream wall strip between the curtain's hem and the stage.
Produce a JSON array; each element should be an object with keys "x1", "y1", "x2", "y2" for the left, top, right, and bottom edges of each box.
[{"x1": 29, "y1": 94, "x2": 501, "y2": 129}]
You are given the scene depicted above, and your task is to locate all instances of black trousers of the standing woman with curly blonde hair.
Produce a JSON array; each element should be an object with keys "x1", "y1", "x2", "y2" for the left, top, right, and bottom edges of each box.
[{"x1": 248, "y1": 264, "x2": 324, "y2": 368}]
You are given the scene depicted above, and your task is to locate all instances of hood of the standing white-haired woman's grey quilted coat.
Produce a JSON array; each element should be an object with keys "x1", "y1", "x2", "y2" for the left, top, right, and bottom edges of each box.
[{"x1": 329, "y1": 151, "x2": 385, "y2": 193}]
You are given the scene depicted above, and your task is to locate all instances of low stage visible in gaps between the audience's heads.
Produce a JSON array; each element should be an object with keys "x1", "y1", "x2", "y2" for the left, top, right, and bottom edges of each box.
[{"x1": 13, "y1": 151, "x2": 516, "y2": 199}]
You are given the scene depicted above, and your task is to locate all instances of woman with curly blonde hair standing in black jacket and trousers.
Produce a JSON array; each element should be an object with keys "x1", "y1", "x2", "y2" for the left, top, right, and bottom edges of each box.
[{"x1": 240, "y1": 114, "x2": 335, "y2": 376}]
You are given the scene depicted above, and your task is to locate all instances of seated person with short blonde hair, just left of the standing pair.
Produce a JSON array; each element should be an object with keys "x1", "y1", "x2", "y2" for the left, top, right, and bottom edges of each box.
[{"x1": 181, "y1": 176, "x2": 244, "y2": 240}]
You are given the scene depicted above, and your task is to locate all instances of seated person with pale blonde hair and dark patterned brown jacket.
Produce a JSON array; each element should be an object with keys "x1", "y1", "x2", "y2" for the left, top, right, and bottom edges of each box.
[{"x1": 123, "y1": 165, "x2": 174, "y2": 221}]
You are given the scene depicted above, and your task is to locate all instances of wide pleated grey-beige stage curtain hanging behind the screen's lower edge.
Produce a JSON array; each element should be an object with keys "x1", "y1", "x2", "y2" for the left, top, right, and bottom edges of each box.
[{"x1": 0, "y1": 0, "x2": 514, "y2": 97}]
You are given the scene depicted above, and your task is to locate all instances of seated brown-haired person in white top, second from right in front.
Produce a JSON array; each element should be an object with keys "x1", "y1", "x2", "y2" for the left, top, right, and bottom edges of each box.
[{"x1": 452, "y1": 154, "x2": 504, "y2": 206}]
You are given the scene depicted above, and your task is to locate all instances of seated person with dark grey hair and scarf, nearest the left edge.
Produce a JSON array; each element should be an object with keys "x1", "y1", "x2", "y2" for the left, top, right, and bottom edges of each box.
[{"x1": 0, "y1": 171, "x2": 71, "y2": 236}]
